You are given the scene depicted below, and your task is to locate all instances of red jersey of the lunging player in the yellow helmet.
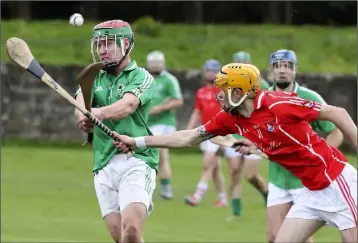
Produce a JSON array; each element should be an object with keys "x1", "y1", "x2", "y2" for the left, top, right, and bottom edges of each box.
[{"x1": 205, "y1": 91, "x2": 347, "y2": 190}]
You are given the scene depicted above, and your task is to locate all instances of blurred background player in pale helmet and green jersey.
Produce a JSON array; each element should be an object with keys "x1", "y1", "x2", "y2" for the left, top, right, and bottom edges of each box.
[{"x1": 147, "y1": 51, "x2": 183, "y2": 199}]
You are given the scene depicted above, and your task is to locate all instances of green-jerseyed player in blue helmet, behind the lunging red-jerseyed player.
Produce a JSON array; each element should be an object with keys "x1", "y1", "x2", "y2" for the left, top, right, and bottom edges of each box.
[{"x1": 267, "y1": 50, "x2": 343, "y2": 242}]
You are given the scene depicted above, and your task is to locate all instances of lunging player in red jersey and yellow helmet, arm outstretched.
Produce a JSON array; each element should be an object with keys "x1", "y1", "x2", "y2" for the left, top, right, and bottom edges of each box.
[{"x1": 114, "y1": 63, "x2": 357, "y2": 243}]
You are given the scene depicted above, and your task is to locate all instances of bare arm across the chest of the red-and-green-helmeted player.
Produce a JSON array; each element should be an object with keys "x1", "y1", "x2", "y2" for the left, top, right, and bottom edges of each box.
[{"x1": 93, "y1": 92, "x2": 140, "y2": 120}]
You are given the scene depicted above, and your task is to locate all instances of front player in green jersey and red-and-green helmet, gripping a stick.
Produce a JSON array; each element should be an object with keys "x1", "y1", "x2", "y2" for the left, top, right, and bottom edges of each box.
[{"x1": 75, "y1": 20, "x2": 159, "y2": 242}]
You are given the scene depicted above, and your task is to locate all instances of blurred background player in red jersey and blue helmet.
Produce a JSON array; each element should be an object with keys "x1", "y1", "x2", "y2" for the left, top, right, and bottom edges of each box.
[{"x1": 185, "y1": 59, "x2": 240, "y2": 207}]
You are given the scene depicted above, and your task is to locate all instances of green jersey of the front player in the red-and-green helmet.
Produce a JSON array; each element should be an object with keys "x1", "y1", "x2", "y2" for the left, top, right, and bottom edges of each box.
[{"x1": 78, "y1": 61, "x2": 159, "y2": 172}]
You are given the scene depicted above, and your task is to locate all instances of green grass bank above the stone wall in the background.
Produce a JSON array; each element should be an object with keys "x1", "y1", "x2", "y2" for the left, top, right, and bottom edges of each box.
[{"x1": 1, "y1": 21, "x2": 357, "y2": 74}]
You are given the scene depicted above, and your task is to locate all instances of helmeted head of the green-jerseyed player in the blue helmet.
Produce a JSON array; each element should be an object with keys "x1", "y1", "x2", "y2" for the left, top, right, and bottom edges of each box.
[{"x1": 269, "y1": 50, "x2": 297, "y2": 89}]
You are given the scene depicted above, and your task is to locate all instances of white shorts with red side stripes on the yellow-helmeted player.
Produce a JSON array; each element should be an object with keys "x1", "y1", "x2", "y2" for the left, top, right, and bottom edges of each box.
[{"x1": 287, "y1": 164, "x2": 357, "y2": 230}]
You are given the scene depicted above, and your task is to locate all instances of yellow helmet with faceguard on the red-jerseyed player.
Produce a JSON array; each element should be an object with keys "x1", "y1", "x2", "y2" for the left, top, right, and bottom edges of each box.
[{"x1": 215, "y1": 63, "x2": 261, "y2": 107}]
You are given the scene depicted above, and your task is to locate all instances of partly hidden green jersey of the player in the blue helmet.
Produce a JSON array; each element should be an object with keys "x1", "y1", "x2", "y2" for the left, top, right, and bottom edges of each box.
[{"x1": 269, "y1": 82, "x2": 336, "y2": 189}]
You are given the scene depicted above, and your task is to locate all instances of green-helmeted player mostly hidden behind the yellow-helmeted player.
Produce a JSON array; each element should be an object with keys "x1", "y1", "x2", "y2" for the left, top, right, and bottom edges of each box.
[{"x1": 232, "y1": 51, "x2": 270, "y2": 207}]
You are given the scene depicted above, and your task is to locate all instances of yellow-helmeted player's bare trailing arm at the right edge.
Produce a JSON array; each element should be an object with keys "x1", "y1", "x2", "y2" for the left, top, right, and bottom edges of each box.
[{"x1": 317, "y1": 105, "x2": 357, "y2": 149}]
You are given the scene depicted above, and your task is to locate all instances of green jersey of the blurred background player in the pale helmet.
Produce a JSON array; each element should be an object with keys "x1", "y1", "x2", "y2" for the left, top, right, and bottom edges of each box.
[{"x1": 148, "y1": 71, "x2": 183, "y2": 126}]
